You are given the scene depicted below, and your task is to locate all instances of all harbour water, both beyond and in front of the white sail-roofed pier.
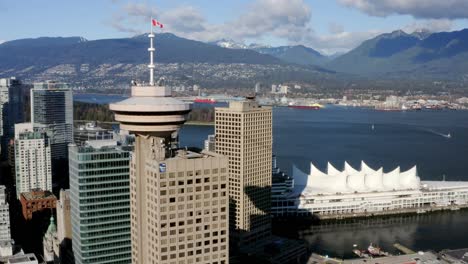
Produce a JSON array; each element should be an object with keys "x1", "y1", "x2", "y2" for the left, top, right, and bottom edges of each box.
[{"x1": 74, "y1": 94, "x2": 468, "y2": 257}]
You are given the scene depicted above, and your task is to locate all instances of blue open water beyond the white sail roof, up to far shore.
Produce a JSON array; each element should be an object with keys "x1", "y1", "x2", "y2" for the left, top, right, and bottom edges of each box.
[{"x1": 180, "y1": 106, "x2": 468, "y2": 180}]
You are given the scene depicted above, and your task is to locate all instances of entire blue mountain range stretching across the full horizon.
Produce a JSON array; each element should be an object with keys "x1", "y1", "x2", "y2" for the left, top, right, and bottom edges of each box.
[{"x1": 0, "y1": 29, "x2": 468, "y2": 86}]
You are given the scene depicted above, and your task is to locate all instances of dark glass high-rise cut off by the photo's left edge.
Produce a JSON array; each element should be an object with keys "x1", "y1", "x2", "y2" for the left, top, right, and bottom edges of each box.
[{"x1": 0, "y1": 77, "x2": 24, "y2": 159}]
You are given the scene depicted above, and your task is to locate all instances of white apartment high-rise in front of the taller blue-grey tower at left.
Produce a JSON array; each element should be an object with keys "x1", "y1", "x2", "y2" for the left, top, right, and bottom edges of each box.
[{"x1": 15, "y1": 123, "x2": 52, "y2": 199}]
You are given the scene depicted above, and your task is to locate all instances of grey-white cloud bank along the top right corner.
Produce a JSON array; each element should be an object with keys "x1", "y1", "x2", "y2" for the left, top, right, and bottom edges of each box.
[{"x1": 338, "y1": 0, "x2": 468, "y2": 19}]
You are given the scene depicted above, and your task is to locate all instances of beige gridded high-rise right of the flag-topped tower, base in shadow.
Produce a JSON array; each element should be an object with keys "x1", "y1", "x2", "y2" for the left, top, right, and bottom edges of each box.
[{"x1": 215, "y1": 98, "x2": 273, "y2": 246}]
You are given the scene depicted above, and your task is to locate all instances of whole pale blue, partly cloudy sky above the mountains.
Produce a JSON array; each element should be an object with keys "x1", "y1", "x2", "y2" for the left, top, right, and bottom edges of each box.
[{"x1": 0, "y1": 0, "x2": 468, "y2": 54}]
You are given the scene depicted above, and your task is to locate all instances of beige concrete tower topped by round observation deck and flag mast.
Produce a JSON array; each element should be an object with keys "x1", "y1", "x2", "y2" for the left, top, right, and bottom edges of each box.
[{"x1": 110, "y1": 23, "x2": 228, "y2": 264}]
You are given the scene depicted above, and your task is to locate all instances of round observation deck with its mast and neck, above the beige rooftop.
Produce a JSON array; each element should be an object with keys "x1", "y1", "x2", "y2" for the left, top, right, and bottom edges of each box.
[{"x1": 110, "y1": 24, "x2": 191, "y2": 157}]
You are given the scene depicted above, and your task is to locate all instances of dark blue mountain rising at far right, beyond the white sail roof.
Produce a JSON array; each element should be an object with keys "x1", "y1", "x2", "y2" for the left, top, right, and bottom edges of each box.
[{"x1": 324, "y1": 29, "x2": 468, "y2": 79}]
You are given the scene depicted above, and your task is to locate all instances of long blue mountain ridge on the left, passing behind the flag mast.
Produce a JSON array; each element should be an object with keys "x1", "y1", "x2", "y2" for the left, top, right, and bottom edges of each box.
[{"x1": 0, "y1": 33, "x2": 282, "y2": 68}]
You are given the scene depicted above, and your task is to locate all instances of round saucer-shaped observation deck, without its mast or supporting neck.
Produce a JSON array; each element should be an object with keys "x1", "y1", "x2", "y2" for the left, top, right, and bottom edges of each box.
[{"x1": 109, "y1": 86, "x2": 191, "y2": 135}]
